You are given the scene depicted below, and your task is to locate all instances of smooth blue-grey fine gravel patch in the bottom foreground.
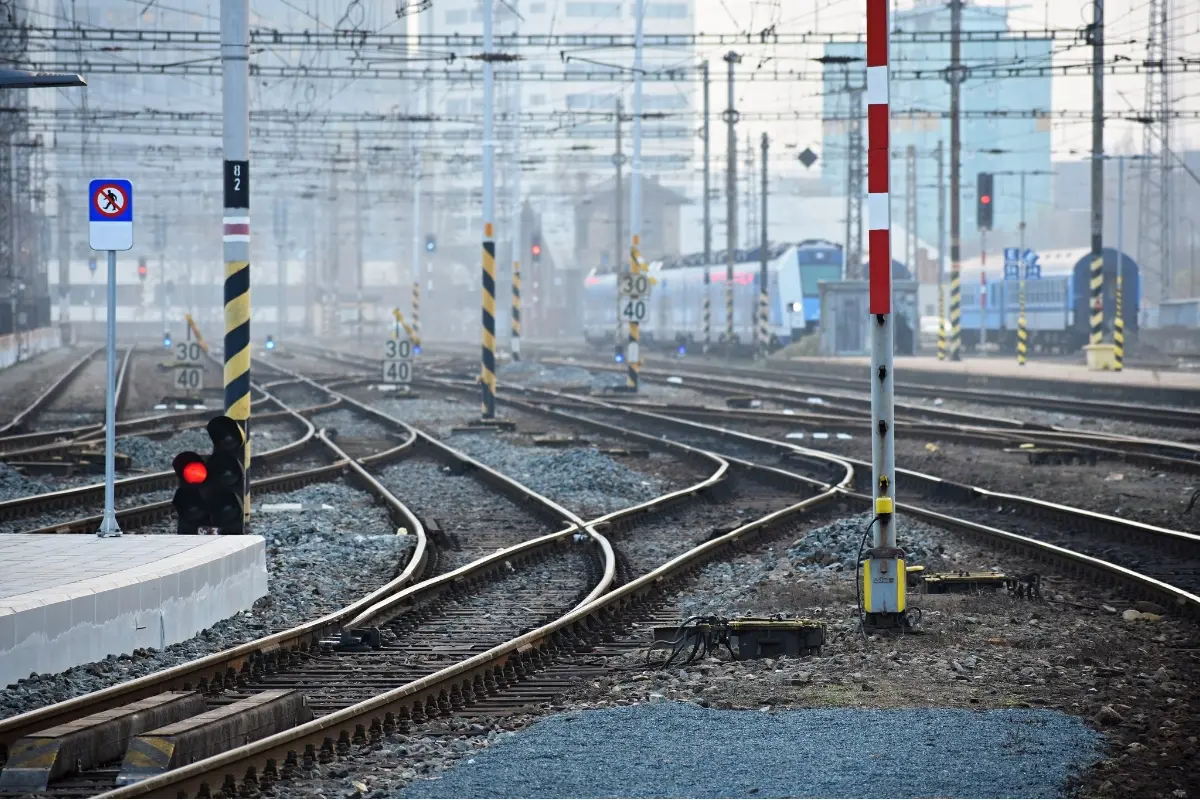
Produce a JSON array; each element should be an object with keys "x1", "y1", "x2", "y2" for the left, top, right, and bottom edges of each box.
[{"x1": 398, "y1": 703, "x2": 1102, "y2": 798}]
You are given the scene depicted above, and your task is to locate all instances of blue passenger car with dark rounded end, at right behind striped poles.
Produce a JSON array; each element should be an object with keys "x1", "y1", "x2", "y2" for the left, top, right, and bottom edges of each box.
[{"x1": 942, "y1": 247, "x2": 1141, "y2": 353}]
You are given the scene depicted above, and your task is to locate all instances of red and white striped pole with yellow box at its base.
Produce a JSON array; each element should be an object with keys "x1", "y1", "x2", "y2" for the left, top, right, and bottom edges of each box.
[{"x1": 863, "y1": 0, "x2": 905, "y2": 627}]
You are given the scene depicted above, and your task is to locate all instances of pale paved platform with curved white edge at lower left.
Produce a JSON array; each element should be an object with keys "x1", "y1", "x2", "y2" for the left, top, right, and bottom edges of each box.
[{"x1": 0, "y1": 534, "x2": 266, "y2": 686}]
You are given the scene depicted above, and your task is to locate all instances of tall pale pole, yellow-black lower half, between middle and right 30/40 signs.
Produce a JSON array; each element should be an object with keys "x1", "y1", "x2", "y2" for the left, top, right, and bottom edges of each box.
[{"x1": 480, "y1": 0, "x2": 496, "y2": 420}]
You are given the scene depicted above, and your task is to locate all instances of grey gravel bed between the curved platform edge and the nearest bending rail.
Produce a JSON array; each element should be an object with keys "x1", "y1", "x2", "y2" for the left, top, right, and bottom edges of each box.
[{"x1": 0, "y1": 474, "x2": 409, "y2": 718}]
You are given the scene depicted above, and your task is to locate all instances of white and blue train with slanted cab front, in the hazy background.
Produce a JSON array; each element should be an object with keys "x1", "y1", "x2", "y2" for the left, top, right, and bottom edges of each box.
[{"x1": 583, "y1": 240, "x2": 842, "y2": 347}]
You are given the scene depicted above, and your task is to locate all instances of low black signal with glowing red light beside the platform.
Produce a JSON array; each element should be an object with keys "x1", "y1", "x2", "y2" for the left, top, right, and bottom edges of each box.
[{"x1": 172, "y1": 416, "x2": 246, "y2": 535}]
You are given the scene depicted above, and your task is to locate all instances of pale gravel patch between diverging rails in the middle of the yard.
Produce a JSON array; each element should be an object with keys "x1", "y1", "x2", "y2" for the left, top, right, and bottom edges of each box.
[{"x1": 448, "y1": 434, "x2": 665, "y2": 518}]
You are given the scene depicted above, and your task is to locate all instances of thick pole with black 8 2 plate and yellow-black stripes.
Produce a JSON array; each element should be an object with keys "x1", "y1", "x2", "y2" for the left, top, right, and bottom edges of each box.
[{"x1": 221, "y1": 0, "x2": 251, "y2": 521}]
